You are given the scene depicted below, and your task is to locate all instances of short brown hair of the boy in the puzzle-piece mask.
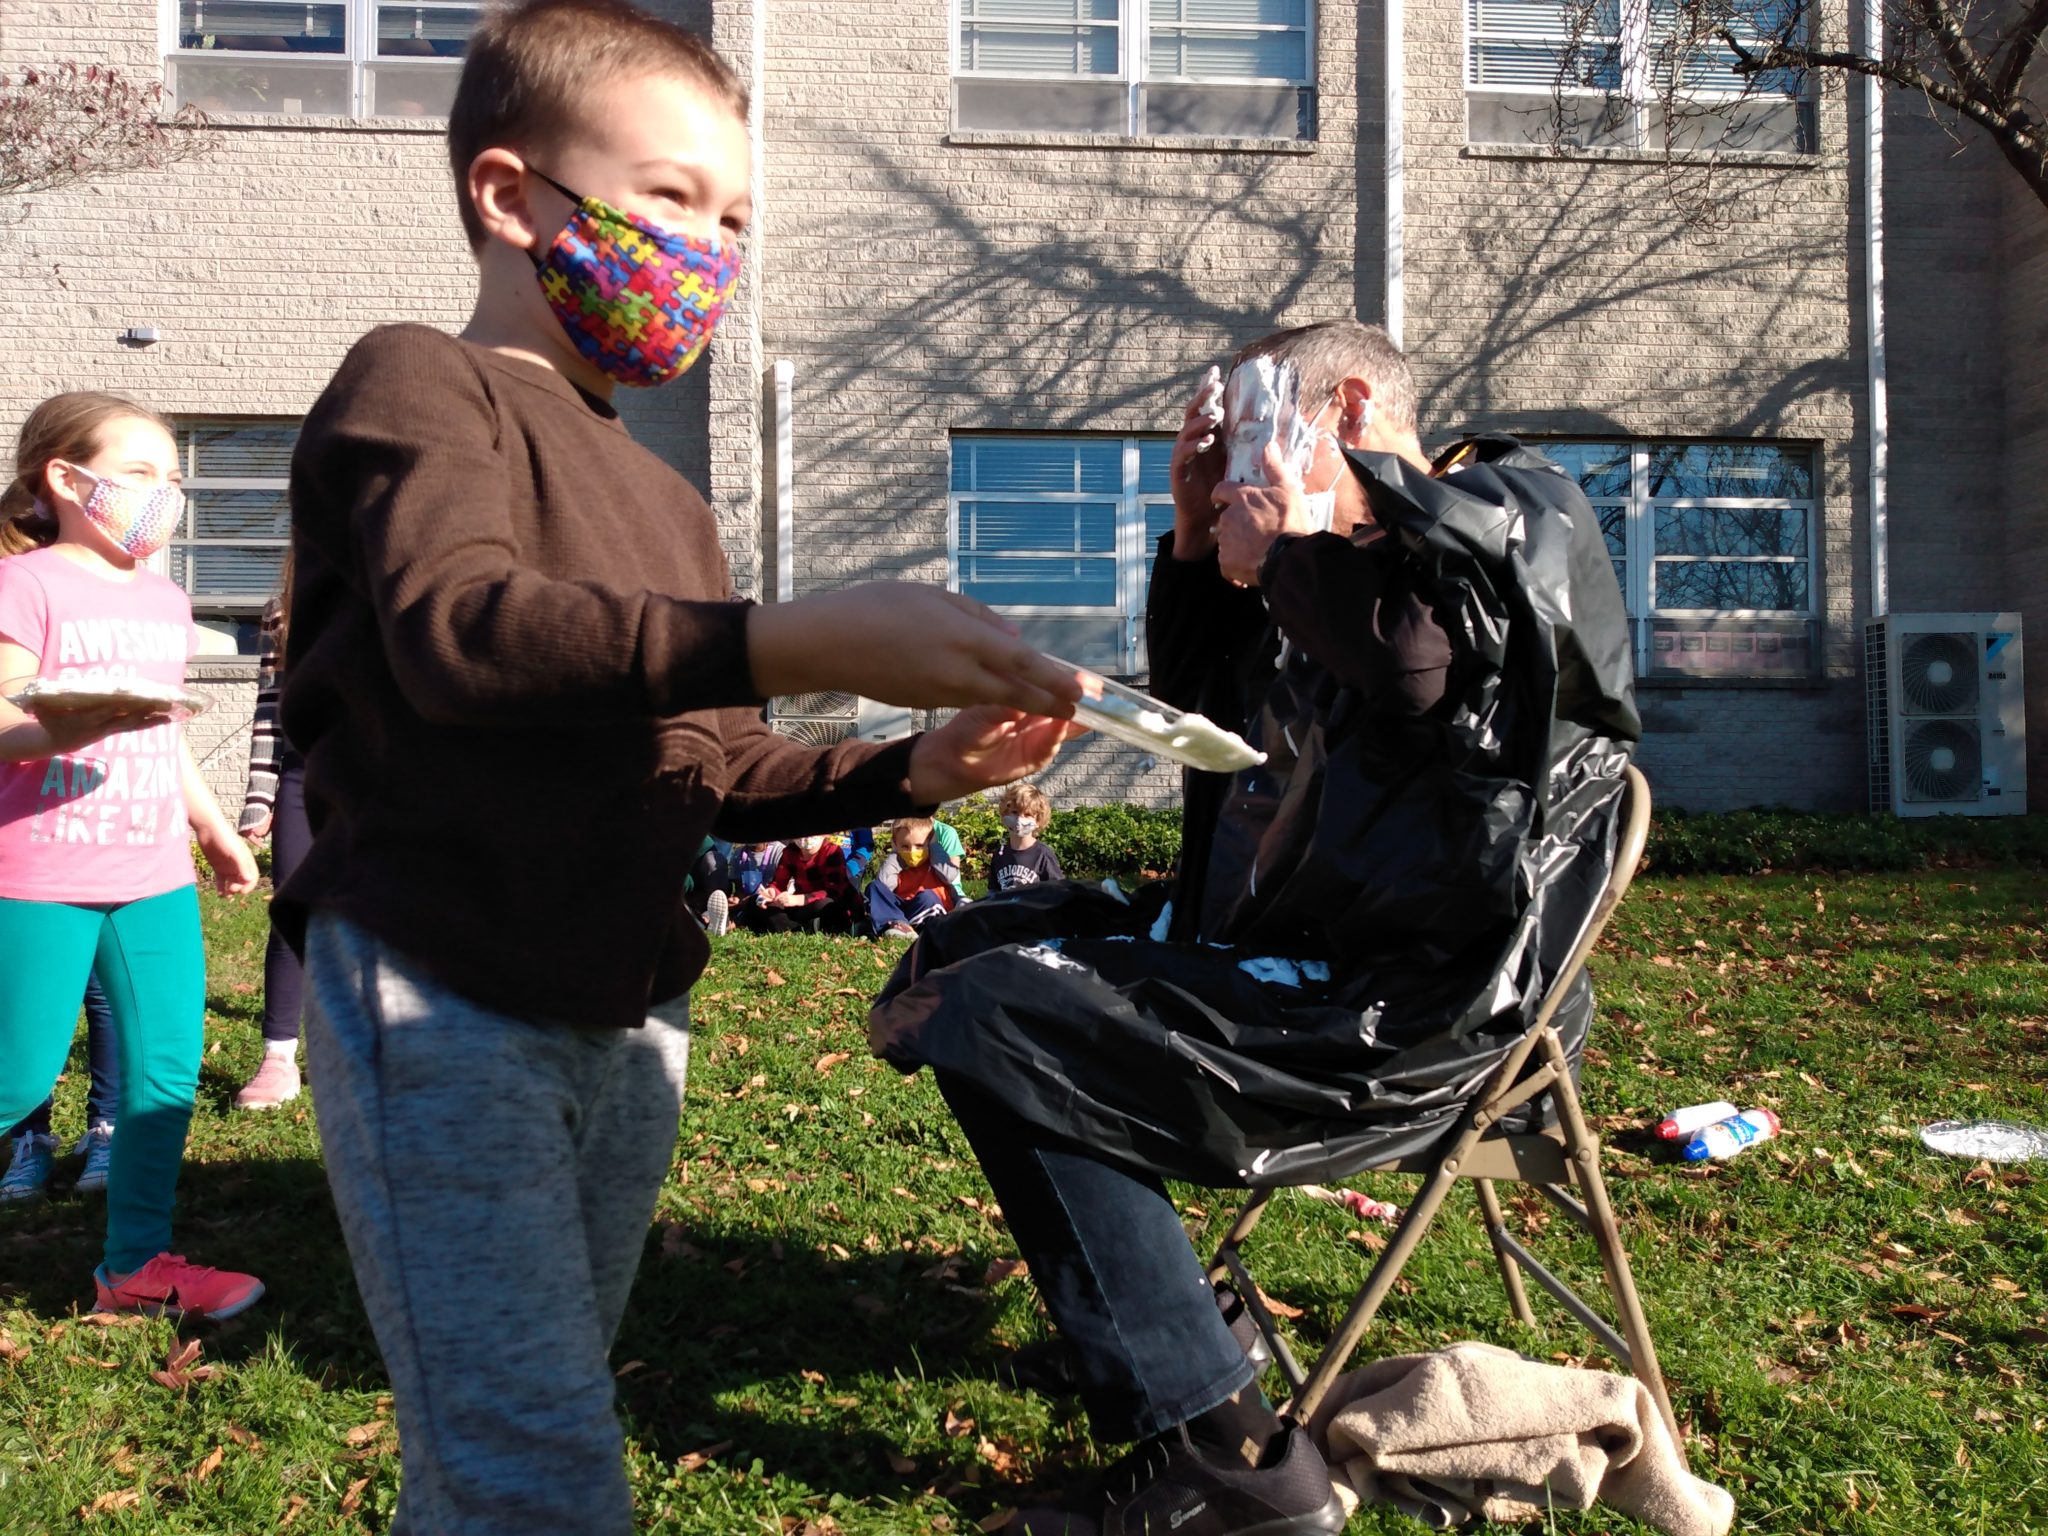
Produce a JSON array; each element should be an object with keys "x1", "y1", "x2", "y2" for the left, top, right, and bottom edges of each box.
[{"x1": 449, "y1": 0, "x2": 748, "y2": 250}]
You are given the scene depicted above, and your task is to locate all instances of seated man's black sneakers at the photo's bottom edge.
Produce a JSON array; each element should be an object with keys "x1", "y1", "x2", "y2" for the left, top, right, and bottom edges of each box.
[{"x1": 1004, "y1": 1423, "x2": 1343, "y2": 1536}]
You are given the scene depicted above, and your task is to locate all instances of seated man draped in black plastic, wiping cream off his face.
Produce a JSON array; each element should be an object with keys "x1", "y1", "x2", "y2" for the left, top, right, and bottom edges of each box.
[{"x1": 872, "y1": 322, "x2": 1638, "y2": 1536}]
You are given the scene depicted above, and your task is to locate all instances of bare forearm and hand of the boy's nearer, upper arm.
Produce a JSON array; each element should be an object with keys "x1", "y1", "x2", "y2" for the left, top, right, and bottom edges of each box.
[{"x1": 748, "y1": 582, "x2": 1081, "y2": 719}]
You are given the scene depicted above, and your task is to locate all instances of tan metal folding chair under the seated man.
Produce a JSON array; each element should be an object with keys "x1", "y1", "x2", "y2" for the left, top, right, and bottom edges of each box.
[{"x1": 1210, "y1": 768, "x2": 1686, "y2": 1456}]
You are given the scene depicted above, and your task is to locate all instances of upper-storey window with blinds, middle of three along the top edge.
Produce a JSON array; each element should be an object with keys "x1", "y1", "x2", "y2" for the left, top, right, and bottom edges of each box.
[{"x1": 952, "y1": 0, "x2": 1315, "y2": 139}]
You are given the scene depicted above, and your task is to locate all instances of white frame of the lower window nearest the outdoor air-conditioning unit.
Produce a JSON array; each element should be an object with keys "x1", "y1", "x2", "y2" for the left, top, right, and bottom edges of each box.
[{"x1": 1532, "y1": 436, "x2": 1825, "y2": 682}]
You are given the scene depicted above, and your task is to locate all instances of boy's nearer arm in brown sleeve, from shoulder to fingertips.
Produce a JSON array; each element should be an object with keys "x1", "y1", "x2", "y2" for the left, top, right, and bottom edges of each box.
[{"x1": 293, "y1": 328, "x2": 1079, "y2": 725}]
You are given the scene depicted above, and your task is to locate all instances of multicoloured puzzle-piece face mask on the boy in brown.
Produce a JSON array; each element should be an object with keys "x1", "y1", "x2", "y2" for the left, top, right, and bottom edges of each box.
[{"x1": 526, "y1": 170, "x2": 739, "y2": 387}]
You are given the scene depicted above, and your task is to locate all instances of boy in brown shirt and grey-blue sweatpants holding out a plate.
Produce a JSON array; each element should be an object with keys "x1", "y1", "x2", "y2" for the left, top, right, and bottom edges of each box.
[{"x1": 279, "y1": 0, "x2": 1077, "y2": 1536}]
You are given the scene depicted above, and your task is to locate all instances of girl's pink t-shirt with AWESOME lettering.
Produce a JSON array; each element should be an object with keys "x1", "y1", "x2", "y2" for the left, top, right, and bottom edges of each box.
[{"x1": 0, "y1": 549, "x2": 197, "y2": 903}]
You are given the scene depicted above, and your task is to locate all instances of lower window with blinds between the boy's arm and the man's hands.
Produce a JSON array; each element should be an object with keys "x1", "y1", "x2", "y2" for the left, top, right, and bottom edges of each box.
[{"x1": 948, "y1": 434, "x2": 1174, "y2": 676}]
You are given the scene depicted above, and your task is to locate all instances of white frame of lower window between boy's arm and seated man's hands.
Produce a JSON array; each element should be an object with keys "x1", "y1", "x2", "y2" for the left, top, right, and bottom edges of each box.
[{"x1": 946, "y1": 430, "x2": 1174, "y2": 678}]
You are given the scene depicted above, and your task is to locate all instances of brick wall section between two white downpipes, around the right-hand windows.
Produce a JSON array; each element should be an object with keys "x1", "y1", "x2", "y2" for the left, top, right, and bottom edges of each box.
[{"x1": 1405, "y1": 6, "x2": 1866, "y2": 809}]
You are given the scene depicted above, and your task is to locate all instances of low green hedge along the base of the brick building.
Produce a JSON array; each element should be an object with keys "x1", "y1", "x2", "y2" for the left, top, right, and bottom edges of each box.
[{"x1": 944, "y1": 801, "x2": 2048, "y2": 881}]
